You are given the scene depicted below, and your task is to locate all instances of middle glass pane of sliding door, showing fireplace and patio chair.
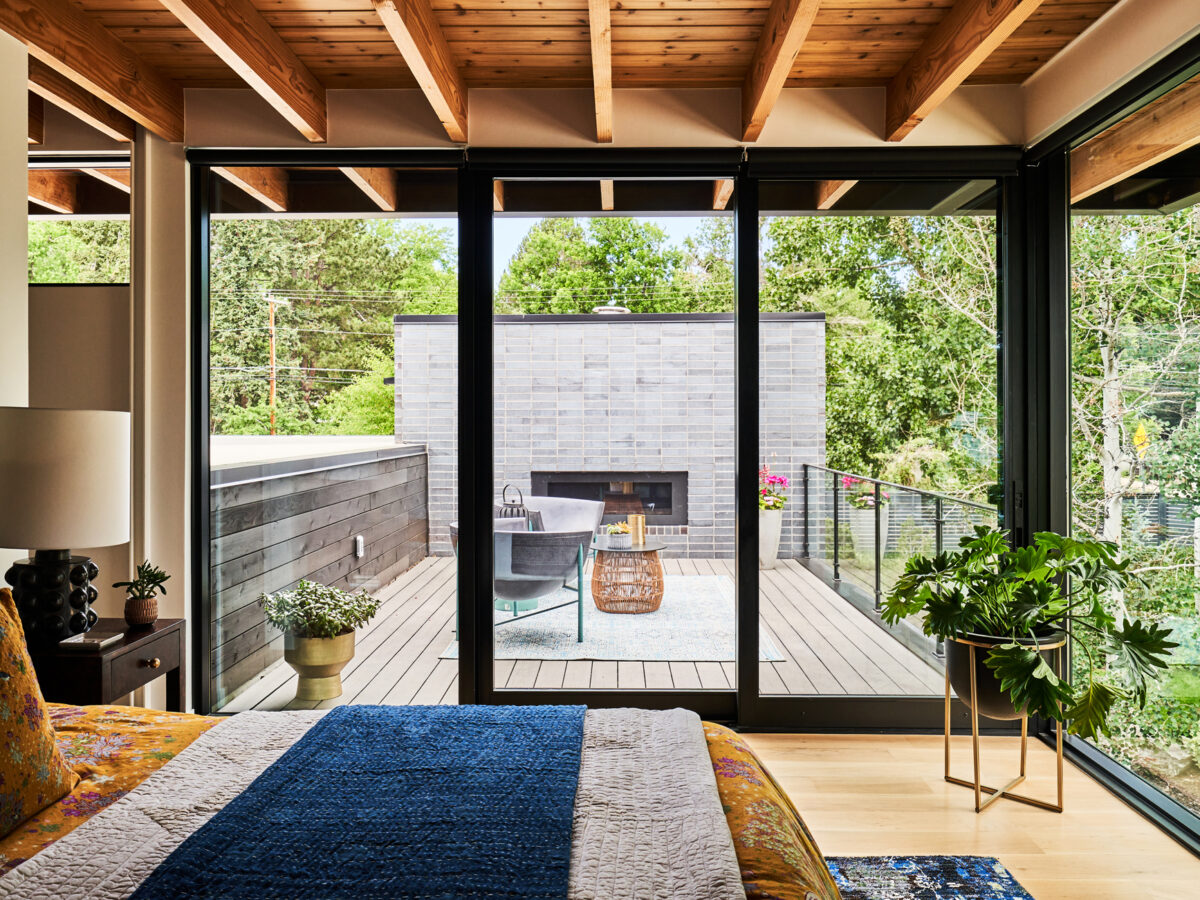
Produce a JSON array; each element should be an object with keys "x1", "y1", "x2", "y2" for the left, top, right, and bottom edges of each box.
[{"x1": 493, "y1": 180, "x2": 737, "y2": 690}]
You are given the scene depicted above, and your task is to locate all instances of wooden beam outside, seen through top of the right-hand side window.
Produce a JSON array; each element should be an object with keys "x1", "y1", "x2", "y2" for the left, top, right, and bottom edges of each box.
[{"x1": 1070, "y1": 80, "x2": 1200, "y2": 203}]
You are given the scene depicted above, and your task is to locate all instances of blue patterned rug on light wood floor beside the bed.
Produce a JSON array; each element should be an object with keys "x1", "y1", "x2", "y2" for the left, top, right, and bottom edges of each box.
[{"x1": 826, "y1": 857, "x2": 1033, "y2": 900}]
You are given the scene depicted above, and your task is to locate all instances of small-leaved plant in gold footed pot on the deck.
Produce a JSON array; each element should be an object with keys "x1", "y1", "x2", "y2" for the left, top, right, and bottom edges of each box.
[{"x1": 258, "y1": 581, "x2": 379, "y2": 700}]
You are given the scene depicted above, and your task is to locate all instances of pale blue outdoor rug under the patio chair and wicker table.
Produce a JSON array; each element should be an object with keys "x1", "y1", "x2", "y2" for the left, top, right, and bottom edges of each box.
[{"x1": 442, "y1": 575, "x2": 784, "y2": 662}]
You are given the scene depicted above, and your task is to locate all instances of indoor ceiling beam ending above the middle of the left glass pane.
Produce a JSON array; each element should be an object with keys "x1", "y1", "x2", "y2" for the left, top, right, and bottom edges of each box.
[{"x1": 160, "y1": 0, "x2": 328, "y2": 142}]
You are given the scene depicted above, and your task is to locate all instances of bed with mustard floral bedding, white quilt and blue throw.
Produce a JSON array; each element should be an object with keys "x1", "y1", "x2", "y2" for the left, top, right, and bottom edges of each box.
[{"x1": 0, "y1": 704, "x2": 838, "y2": 900}]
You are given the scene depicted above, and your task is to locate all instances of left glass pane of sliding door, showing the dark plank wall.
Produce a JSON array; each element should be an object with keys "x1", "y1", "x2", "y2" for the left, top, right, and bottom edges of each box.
[{"x1": 208, "y1": 168, "x2": 457, "y2": 712}]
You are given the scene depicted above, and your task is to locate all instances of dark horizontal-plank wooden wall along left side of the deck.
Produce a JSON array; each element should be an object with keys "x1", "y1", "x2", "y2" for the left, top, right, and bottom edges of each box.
[{"x1": 209, "y1": 444, "x2": 428, "y2": 708}]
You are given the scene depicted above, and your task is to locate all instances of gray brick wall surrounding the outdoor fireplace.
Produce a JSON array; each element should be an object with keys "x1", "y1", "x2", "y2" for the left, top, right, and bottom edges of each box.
[{"x1": 395, "y1": 314, "x2": 824, "y2": 558}]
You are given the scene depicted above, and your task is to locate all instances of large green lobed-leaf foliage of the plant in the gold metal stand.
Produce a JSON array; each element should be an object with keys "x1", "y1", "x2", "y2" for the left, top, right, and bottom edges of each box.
[{"x1": 883, "y1": 526, "x2": 1178, "y2": 738}]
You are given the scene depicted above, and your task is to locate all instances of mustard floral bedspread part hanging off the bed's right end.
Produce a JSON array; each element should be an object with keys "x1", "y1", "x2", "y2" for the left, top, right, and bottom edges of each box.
[{"x1": 704, "y1": 722, "x2": 841, "y2": 900}]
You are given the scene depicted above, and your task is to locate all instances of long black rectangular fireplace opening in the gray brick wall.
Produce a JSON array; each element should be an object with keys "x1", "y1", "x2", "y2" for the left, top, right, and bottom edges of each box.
[{"x1": 530, "y1": 472, "x2": 688, "y2": 526}]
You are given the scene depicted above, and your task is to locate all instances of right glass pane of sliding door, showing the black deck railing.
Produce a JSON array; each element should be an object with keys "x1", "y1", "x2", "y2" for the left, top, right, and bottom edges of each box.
[{"x1": 758, "y1": 181, "x2": 998, "y2": 696}]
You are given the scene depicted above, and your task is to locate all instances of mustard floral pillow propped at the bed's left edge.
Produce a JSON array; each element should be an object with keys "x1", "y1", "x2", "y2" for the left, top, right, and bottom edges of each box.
[{"x1": 0, "y1": 588, "x2": 79, "y2": 838}]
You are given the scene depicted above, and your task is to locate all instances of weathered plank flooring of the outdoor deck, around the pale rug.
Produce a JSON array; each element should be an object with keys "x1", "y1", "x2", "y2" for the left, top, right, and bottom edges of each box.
[{"x1": 224, "y1": 557, "x2": 943, "y2": 712}]
